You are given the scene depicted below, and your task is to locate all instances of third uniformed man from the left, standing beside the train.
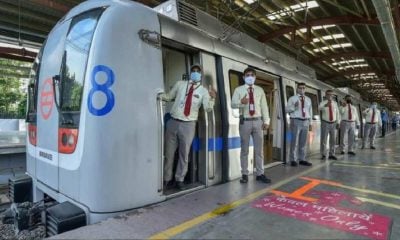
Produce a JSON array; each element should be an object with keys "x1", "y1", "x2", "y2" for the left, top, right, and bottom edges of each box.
[{"x1": 286, "y1": 83, "x2": 313, "y2": 167}]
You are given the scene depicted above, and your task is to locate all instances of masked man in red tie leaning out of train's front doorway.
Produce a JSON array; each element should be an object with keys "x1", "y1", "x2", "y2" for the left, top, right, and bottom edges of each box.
[{"x1": 161, "y1": 64, "x2": 216, "y2": 190}]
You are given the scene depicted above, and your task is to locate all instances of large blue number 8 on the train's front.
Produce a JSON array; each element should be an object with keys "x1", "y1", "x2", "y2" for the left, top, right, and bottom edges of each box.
[{"x1": 88, "y1": 65, "x2": 115, "y2": 116}]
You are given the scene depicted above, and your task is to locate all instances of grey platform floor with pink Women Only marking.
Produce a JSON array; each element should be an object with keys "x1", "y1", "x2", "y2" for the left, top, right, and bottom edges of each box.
[{"x1": 52, "y1": 131, "x2": 400, "y2": 239}]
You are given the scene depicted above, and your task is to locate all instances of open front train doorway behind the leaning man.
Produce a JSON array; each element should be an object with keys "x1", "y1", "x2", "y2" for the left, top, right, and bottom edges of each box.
[{"x1": 162, "y1": 39, "x2": 222, "y2": 197}]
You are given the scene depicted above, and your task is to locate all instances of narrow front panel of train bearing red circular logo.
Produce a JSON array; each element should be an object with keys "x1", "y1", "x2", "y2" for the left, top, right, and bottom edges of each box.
[{"x1": 34, "y1": 20, "x2": 71, "y2": 192}]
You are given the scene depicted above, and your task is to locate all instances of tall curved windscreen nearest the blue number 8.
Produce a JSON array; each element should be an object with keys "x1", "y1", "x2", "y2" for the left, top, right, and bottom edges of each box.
[{"x1": 60, "y1": 9, "x2": 103, "y2": 125}]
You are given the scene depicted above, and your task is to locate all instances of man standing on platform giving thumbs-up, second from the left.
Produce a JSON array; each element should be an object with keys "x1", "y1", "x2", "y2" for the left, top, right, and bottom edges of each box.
[{"x1": 231, "y1": 68, "x2": 271, "y2": 183}]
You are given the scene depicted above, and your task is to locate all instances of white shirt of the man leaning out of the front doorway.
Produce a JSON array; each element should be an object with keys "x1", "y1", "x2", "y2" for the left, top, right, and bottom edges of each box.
[{"x1": 161, "y1": 81, "x2": 214, "y2": 121}]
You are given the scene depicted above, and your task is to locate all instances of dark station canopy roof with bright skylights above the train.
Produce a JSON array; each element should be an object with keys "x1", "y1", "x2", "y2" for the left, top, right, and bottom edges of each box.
[{"x1": 0, "y1": 0, "x2": 400, "y2": 111}]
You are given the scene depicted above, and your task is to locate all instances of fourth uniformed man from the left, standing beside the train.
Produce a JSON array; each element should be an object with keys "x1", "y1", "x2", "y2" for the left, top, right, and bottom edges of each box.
[{"x1": 318, "y1": 89, "x2": 340, "y2": 160}]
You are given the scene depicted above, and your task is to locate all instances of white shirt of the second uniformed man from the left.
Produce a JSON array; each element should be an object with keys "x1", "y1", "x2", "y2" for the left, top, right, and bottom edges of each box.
[{"x1": 231, "y1": 84, "x2": 270, "y2": 124}]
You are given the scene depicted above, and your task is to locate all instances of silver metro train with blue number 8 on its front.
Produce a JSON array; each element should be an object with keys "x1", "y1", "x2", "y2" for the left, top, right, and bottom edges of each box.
[{"x1": 20, "y1": 0, "x2": 374, "y2": 230}]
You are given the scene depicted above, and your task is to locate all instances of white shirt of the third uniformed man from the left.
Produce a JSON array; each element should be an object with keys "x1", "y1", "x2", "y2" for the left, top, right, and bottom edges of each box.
[{"x1": 286, "y1": 94, "x2": 313, "y2": 119}]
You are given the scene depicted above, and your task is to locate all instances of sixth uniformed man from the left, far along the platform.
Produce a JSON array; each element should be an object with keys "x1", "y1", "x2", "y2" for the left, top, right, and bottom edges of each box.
[{"x1": 361, "y1": 102, "x2": 382, "y2": 149}]
